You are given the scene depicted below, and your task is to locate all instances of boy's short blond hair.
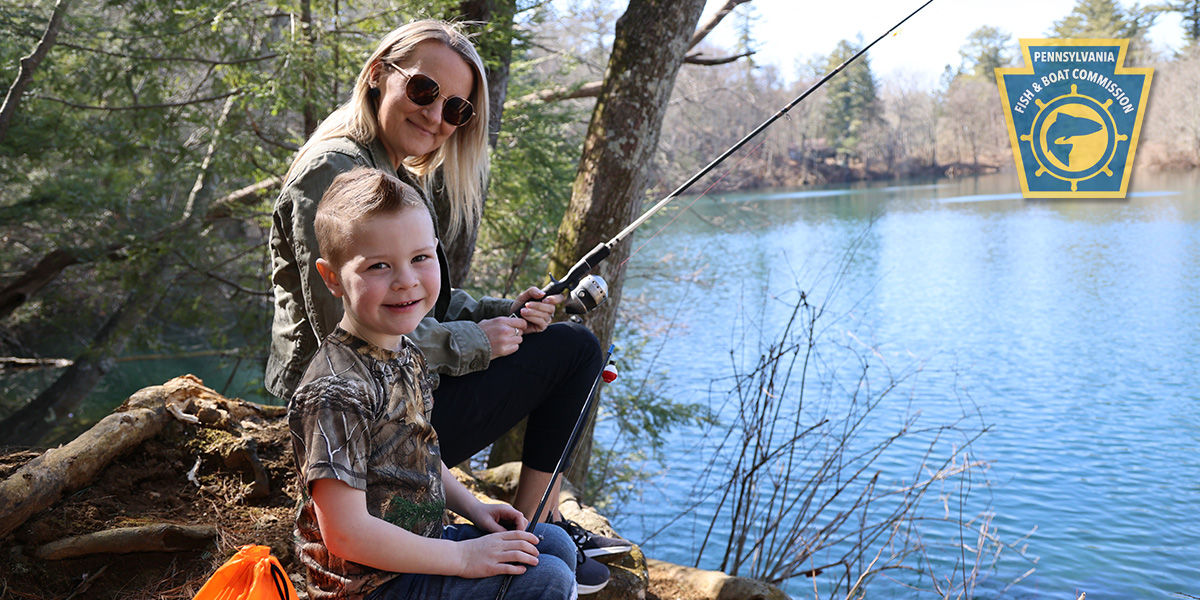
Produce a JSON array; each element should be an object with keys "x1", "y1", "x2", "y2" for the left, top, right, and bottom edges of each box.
[{"x1": 313, "y1": 167, "x2": 426, "y2": 269}]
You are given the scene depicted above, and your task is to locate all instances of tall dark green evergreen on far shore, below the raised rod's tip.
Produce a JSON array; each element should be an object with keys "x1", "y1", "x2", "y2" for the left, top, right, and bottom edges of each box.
[{"x1": 822, "y1": 40, "x2": 878, "y2": 162}]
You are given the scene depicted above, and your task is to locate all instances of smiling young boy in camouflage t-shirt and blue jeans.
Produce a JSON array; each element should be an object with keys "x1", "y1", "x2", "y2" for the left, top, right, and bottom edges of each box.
[{"x1": 288, "y1": 168, "x2": 576, "y2": 600}]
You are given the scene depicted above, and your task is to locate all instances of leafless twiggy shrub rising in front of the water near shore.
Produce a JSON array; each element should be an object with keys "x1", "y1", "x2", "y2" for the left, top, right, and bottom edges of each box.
[{"x1": 680, "y1": 238, "x2": 1028, "y2": 599}]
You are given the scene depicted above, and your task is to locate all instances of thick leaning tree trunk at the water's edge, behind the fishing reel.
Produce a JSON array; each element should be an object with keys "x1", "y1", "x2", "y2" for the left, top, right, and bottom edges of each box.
[{"x1": 551, "y1": 0, "x2": 704, "y2": 485}]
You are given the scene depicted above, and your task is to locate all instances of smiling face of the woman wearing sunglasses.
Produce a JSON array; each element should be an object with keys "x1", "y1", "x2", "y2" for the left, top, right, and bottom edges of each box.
[{"x1": 377, "y1": 40, "x2": 474, "y2": 167}]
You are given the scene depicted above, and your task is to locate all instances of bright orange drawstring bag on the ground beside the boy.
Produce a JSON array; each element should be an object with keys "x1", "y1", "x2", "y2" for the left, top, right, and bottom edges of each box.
[{"x1": 193, "y1": 545, "x2": 296, "y2": 600}]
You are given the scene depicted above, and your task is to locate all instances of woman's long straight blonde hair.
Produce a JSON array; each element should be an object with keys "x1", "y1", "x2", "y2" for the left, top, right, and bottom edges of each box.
[{"x1": 284, "y1": 19, "x2": 488, "y2": 242}]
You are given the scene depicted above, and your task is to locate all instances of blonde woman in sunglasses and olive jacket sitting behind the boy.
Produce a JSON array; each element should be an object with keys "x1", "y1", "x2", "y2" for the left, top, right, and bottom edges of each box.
[{"x1": 265, "y1": 20, "x2": 630, "y2": 593}]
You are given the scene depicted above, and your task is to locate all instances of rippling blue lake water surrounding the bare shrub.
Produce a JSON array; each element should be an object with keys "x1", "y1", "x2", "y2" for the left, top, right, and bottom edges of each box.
[{"x1": 598, "y1": 174, "x2": 1200, "y2": 600}]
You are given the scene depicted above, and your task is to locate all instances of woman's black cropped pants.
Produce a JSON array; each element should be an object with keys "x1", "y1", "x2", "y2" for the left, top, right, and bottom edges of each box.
[{"x1": 433, "y1": 323, "x2": 604, "y2": 473}]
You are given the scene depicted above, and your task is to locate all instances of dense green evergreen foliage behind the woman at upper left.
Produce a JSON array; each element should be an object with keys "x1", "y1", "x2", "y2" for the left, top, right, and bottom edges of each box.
[{"x1": 0, "y1": 0, "x2": 446, "y2": 427}]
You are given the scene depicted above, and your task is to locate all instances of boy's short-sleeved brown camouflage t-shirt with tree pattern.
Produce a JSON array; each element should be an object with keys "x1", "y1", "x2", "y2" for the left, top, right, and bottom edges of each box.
[{"x1": 288, "y1": 328, "x2": 445, "y2": 600}]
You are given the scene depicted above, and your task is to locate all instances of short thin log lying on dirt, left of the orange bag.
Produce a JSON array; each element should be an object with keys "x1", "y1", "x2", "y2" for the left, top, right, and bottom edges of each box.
[{"x1": 34, "y1": 523, "x2": 217, "y2": 560}]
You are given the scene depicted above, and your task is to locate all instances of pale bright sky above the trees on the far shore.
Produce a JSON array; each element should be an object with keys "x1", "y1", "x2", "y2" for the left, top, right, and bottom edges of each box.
[{"x1": 701, "y1": 0, "x2": 1183, "y2": 88}]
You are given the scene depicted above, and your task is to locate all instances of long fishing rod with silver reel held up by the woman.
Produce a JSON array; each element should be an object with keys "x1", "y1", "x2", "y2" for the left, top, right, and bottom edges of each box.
[{"x1": 535, "y1": 0, "x2": 934, "y2": 316}]
